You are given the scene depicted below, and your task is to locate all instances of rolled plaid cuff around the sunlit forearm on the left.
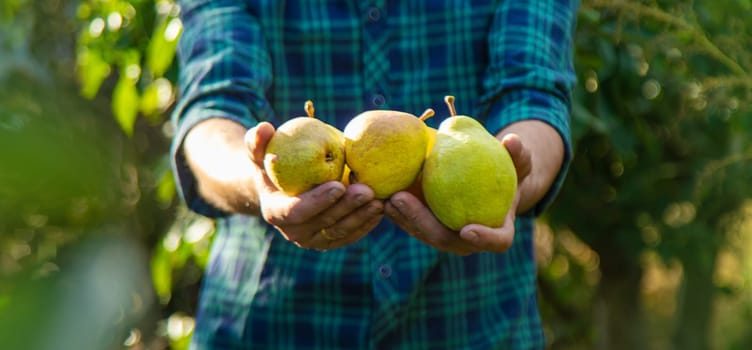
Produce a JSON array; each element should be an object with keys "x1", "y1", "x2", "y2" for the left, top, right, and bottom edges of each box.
[{"x1": 170, "y1": 99, "x2": 257, "y2": 218}]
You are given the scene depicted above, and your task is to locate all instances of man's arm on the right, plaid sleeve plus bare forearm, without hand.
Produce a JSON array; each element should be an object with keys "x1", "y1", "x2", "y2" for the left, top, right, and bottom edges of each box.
[{"x1": 481, "y1": 0, "x2": 579, "y2": 215}]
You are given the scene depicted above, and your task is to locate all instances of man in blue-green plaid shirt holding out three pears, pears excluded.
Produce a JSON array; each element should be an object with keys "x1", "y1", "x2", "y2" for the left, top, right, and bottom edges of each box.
[{"x1": 173, "y1": 0, "x2": 578, "y2": 349}]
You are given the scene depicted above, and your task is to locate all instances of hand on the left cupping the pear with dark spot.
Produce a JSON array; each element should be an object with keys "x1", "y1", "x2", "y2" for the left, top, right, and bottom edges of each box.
[{"x1": 245, "y1": 123, "x2": 384, "y2": 250}]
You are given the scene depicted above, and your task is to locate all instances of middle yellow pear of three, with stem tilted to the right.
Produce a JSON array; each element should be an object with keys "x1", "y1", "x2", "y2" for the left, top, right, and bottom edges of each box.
[{"x1": 344, "y1": 109, "x2": 433, "y2": 199}]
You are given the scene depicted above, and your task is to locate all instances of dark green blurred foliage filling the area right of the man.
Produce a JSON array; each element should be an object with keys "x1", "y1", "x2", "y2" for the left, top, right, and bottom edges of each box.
[{"x1": 540, "y1": 0, "x2": 752, "y2": 349}]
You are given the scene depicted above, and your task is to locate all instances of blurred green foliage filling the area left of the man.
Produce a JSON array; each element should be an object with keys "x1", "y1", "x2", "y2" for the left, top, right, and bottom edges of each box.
[{"x1": 0, "y1": 0, "x2": 203, "y2": 349}]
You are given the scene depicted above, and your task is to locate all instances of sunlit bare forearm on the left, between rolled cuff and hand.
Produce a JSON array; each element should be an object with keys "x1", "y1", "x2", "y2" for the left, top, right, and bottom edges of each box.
[{"x1": 183, "y1": 118, "x2": 260, "y2": 215}]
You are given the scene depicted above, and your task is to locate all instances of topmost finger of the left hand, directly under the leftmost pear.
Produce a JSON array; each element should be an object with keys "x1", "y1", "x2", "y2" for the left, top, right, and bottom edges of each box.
[{"x1": 261, "y1": 181, "x2": 345, "y2": 230}]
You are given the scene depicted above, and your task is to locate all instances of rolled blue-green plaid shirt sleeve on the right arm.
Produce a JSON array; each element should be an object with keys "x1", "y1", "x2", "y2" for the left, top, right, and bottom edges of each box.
[{"x1": 481, "y1": 0, "x2": 579, "y2": 215}]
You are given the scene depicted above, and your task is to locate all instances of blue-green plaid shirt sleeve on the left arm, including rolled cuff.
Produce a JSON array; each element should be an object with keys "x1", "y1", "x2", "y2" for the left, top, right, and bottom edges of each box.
[{"x1": 171, "y1": 0, "x2": 272, "y2": 217}]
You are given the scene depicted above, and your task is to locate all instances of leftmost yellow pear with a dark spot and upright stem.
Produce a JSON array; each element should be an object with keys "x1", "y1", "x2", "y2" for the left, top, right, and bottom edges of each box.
[{"x1": 264, "y1": 101, "x2": 345, "y2": 196}]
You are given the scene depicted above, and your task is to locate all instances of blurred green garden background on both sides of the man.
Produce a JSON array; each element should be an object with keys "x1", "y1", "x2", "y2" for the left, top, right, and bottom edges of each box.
[{"x1": 0, "y1": 0, "x2": 752, "y2": 350}]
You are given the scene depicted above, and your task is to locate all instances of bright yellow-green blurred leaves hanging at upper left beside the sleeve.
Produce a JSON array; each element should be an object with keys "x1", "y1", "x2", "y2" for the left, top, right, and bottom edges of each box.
[{"x1": 76, "y1": 0, "x2": 183, "y2": 135}]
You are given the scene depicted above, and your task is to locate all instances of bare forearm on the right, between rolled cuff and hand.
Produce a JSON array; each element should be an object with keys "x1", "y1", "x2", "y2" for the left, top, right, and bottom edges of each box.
[{"x1": 497, "y1": 120, "x2": 564, "y2": 213}]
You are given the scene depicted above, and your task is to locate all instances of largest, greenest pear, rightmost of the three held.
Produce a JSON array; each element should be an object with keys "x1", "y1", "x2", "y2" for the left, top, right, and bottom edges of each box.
[{"x1": 422, "y1": 96, "x2": 517, "y2": 231}]
